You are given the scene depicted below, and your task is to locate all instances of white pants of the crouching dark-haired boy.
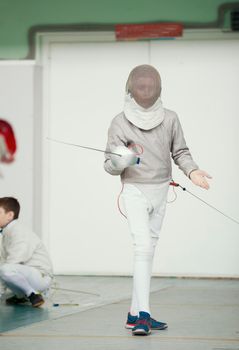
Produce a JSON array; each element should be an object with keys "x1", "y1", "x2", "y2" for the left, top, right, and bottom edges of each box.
[{"x1": 0, "y1": 264, "x2": 52, "y2": 298}]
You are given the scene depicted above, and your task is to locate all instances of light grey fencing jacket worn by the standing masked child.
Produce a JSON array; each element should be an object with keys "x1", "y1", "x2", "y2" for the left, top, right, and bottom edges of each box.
[{"x1": 104, "y1": 109, "x2": 198, "y2": 184}]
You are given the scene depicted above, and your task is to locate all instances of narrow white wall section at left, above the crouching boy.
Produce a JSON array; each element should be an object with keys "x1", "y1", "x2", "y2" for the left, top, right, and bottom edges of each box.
[{"x1": 0, "y1": 61, "x2": 35, "y2": 227}]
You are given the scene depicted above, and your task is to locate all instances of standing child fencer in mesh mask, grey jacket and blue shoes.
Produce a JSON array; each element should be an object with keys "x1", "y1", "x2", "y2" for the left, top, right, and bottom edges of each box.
[{"x1": 104, "y1": 65, "x2": 210, "y2": 335}]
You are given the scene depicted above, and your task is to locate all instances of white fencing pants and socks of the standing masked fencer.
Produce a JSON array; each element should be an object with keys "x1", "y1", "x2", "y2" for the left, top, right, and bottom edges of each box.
[{"x1": 122, "y1": 182, "x2": 169, "y2": 315}]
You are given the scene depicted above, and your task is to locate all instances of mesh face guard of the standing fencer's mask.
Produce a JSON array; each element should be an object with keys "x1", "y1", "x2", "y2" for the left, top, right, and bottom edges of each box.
[{"x1": 126, "y1": 64, "x2": 161, "y2": 108}]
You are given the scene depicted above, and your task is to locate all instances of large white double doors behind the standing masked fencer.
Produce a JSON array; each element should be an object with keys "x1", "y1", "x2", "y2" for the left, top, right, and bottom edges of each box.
[{"x1": 37, "y1": 38, "x2": 239, "y2": 276}]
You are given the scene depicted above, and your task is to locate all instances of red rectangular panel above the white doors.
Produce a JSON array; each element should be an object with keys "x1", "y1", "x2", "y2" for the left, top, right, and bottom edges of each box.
[{"x1": 115, "y1": 23, "x2": 183, "y2": 40}]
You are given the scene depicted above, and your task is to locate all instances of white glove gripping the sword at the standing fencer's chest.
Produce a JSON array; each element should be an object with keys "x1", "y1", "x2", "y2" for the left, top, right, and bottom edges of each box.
[{"x1": 110, "y1": 146, "x2": 138, "y2": 170}]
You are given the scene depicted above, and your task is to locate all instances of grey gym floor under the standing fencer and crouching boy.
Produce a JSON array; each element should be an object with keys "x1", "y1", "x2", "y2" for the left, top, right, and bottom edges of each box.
[{"x1": 0, "y1": 276, "x2": 239, "y2": 350}]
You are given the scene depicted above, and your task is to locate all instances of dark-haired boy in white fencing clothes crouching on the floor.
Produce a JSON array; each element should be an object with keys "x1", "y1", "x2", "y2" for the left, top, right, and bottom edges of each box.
[{"x1": 0, "y1": 197, "x2": 53, "y2": 307}]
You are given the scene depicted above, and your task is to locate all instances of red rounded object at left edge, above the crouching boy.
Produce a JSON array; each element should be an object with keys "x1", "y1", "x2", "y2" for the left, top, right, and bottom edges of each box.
[{"x1": 0, "y1": 119, "x2": 17, "y2": 163}]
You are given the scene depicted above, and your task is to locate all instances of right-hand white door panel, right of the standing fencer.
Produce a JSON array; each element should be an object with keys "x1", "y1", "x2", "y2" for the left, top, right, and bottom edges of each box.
[{"x1": 151, "y1": 40, "x2": 239, "y2": 276}]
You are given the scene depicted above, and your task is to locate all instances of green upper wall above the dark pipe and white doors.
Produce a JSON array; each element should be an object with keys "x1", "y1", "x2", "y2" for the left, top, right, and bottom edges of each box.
[{"x1": 0, "y1": 0, "x2": 236, "y2": 59}]
